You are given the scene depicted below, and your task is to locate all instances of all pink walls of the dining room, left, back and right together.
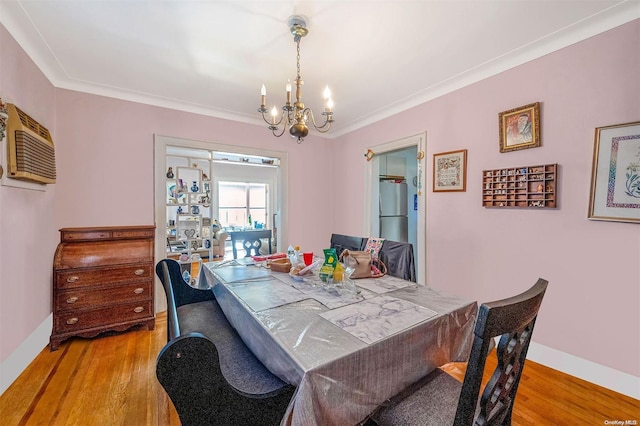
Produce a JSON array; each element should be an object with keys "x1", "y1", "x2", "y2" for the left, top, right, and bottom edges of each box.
[{"x1": 0, "y1": 21, "x2": 640, "y2": 382}]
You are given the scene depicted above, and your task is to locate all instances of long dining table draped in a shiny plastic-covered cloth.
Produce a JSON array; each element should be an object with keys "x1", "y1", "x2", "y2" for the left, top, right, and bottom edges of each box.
[{"x1": 200, "y1": 261, "x2": 477, "y2": 426}]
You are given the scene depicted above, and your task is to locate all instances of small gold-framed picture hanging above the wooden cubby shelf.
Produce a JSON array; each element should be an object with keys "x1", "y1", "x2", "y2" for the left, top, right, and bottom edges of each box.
[{"x1": 498, "y1": 102, "x2": 540, "y2": 152}]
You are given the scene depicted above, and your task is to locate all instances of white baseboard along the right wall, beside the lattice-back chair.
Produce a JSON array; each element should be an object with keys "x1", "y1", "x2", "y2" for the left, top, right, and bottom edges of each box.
[{"x1": 527, "y1": 342, "x2": 640, "y2": 399}]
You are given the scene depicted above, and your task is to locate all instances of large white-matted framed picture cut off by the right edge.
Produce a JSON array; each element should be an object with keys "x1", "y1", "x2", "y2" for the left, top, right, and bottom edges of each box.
[{"x1": 589, "y1": 121, "x2": 640, "y2": 223}]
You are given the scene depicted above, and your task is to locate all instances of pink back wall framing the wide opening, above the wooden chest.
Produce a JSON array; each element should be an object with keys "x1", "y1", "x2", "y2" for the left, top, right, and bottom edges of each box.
[{"x1": 56, "y1": 90, "x2": 333, "y2": 249}]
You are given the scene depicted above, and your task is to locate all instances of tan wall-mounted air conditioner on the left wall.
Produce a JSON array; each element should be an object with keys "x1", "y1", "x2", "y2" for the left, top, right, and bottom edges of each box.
[{"x1": 6, "y1": 104, "x2": 56, "y2": 185}]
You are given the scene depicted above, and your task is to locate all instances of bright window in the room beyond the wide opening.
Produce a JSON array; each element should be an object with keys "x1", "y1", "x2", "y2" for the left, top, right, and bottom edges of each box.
[{"x1": 218, "y1": 181, "x2": 269, "y2": 228}]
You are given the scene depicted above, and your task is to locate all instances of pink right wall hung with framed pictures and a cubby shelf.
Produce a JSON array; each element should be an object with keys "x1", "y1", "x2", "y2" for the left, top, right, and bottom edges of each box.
[{"x1": 335, "y1": 20, "x2": 640, "y2": 376}]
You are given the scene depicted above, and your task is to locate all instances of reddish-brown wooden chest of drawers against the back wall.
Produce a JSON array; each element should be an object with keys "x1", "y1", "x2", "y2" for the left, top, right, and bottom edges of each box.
[{"x1": 49, "y1": 226, "x2": 155, "y2": 351}]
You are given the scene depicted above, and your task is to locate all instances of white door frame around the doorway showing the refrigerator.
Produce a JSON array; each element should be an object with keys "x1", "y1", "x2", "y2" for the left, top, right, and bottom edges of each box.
[{"x1": 364, "y1": 132, "x2": 427, "y2": 285}]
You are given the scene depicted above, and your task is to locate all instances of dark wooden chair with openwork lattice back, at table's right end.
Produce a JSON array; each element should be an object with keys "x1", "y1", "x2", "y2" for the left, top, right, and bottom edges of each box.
[{"x1": 372, "y1": 278, "x2": 548, "y2": 426}]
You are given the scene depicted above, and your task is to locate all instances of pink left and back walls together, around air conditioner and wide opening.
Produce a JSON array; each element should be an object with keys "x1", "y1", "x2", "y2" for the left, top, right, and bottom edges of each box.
[{"x1": 0, "y1": 26, "x2": 333, "y2": 361}]
